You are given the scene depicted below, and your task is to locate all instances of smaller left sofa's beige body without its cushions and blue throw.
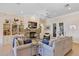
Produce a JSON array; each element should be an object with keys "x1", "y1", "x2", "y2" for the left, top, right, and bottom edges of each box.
[{"x1": 13, "y1": 41, "x2": 38, "y2": 56}]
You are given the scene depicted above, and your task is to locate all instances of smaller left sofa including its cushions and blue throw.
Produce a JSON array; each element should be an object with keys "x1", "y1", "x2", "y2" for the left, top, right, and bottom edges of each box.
[{"x1": 12, "y1": 37, "x2": 38, "y2": 56}]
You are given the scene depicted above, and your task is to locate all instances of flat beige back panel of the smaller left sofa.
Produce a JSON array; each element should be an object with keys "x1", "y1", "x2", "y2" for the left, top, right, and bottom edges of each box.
[{"x1": 17, "y1": 43, "x2": 32, "y2": 56}]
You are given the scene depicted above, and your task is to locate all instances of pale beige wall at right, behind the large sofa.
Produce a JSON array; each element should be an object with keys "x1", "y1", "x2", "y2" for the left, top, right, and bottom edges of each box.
[{"x1": 48, "y1": 12, "x2": 79, "y2": 42}]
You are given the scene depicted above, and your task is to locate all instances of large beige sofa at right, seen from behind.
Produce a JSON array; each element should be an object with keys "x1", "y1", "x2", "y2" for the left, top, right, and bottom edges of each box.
[{"x1": 39, "y1": 36, "x2": 72, "y2": 56}]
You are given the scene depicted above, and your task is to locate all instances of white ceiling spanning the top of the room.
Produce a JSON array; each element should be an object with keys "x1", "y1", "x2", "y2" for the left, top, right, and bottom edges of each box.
[{"x1": 0, "y1": 3, "x2": 79, "y2": 17}]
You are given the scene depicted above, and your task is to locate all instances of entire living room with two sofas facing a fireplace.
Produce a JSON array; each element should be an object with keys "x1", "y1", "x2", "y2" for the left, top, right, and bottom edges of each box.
[{"x1": 0, "y1": 3, "x2": 79, "y2": 56}]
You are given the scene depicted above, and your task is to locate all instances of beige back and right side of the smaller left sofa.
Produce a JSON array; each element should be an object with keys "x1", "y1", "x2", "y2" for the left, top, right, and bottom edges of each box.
[{"x1": 17, "y1": 43, "x2": 37, "y2": 56}]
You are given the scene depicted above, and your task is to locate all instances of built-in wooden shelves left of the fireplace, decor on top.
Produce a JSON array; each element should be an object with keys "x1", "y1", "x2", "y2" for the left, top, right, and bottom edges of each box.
[{"x1": 3, "y1": 19, "x2": 24, "y2": 35}]
